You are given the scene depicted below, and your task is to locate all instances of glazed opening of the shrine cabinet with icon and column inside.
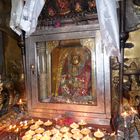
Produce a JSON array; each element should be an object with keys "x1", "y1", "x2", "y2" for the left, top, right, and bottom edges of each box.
[{"x1": 36, "y1": 38, "x2": 96, "y2": 105}]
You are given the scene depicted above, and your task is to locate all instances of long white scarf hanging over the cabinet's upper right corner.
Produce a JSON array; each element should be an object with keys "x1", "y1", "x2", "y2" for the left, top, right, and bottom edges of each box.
[{"x1": 96, "y1": 0, "x2": 120, "y2": 56}]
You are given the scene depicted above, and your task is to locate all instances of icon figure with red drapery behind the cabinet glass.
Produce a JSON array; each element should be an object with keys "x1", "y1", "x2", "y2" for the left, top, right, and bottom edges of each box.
[{"x1": 58, "y1": 48, "x2": 91, "y2": 96}]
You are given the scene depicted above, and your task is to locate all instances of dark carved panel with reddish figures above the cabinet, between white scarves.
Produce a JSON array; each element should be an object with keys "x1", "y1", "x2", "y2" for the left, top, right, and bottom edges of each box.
[{"x1": 38, "y1": 0, "x2": 97, "y2": 27}]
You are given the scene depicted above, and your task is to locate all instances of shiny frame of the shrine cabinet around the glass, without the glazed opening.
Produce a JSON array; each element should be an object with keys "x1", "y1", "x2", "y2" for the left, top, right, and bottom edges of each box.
[{"x1": 26, "y1": 24, "x2": 111, "y2": 125}]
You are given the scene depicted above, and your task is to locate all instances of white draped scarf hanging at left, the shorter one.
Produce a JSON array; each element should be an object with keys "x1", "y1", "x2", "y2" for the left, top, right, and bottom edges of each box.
[{"x1": 10, "y1": 0, "x2": 45, "y2": 36}]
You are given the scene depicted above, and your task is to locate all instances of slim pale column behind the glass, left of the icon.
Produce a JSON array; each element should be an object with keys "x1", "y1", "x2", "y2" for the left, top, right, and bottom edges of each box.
[{"x1": 37, "y1": 42, "x2": 48, "y2": 100}]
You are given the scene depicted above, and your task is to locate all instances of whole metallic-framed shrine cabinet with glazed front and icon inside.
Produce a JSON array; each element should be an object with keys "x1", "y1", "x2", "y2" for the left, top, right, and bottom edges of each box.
[{"x1": 26, "y1": 24, "x2": 111, "y2": 125}]
